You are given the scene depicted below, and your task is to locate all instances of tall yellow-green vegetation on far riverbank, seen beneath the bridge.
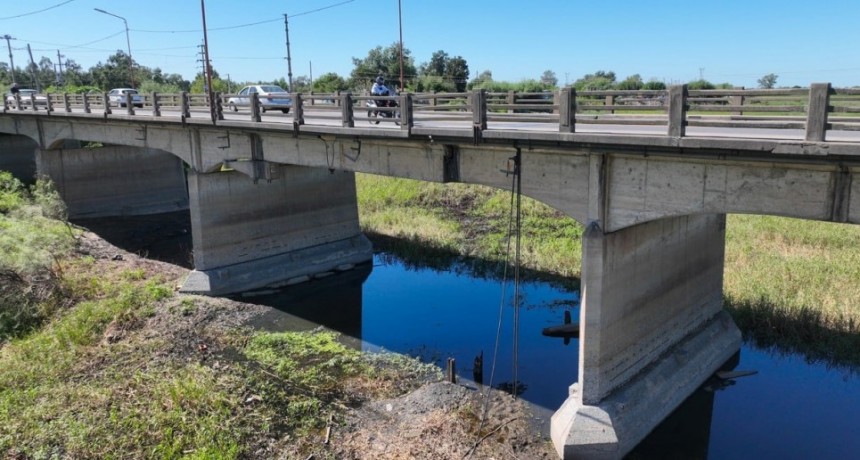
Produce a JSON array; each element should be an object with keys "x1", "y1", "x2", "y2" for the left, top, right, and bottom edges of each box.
[{"x1": 358, "y1": 175, "x2": 860, "y2": 369}]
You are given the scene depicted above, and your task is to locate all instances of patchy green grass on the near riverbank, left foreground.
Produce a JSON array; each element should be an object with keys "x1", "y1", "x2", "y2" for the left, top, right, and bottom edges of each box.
[{"x1": 0, "y1": 175, "x2": 439, "y2": 459}]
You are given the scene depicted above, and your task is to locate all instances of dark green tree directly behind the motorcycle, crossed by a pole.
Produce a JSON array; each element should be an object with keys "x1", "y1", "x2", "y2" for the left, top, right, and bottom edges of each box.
[{"x1": 350, "y1": 42, "x2": 418, "y2": 89}]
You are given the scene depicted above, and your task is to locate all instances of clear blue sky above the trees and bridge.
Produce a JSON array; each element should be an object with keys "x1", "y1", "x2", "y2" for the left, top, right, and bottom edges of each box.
[{"x1": 0, "y1": 0, "x2": 860, "y2": 87}]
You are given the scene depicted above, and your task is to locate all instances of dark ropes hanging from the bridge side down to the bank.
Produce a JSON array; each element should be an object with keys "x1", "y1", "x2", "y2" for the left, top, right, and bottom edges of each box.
[{"x1": 465, "y1": 147, "x2": 522, "y2": 458}]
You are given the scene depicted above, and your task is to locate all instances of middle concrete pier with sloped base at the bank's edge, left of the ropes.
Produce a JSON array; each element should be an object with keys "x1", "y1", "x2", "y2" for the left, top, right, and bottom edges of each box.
[{"x1": 181, "y1": 166, "x2": 373, "y2": 295}]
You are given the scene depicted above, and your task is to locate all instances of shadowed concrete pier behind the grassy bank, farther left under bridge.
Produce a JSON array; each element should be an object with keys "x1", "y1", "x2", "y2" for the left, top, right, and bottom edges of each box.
[{"x1": 36, "y1": 146, "x2": 188, "y2": 218}]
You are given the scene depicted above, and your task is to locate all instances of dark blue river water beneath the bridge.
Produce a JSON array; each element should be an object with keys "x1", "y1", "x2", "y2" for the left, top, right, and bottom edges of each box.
[{"x1": 242, "y1": 253, "x2": 860, "y2": 459}]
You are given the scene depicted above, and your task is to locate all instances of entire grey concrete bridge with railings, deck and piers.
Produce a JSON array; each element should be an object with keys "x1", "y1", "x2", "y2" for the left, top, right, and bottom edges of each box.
[{"x1": 0, "y1": 84, "x2": 860, "y2": 458}]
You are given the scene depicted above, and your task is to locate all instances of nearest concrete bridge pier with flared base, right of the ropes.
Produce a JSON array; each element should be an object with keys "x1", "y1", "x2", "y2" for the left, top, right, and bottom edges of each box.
[{"x1": 551, "y1": 214, "x2": 741, "y2": 458}]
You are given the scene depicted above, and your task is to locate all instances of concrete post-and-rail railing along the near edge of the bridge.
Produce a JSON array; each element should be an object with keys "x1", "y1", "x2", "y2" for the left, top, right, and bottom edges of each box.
[{"x1": 3, "y1": 83, "x2": 860, "y2": 141}]
